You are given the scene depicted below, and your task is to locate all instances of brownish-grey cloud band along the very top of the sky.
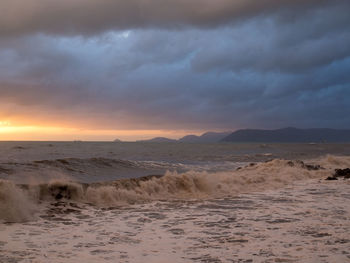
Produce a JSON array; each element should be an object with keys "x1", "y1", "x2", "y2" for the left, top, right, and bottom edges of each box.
[{"x1": 0, "y1": 0, "x2": 340, "y2": 35}]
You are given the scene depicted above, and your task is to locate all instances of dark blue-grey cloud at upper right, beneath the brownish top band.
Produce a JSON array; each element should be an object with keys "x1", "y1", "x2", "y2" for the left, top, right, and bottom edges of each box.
[{"x1": 192, "y1": 2, "x2": 350, "y2": 73}]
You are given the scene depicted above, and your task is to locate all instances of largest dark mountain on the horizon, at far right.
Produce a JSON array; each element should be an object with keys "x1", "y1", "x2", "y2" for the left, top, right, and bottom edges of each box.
[{"x1": 221, "y1": 128, "x2": 350, "y2": 143}]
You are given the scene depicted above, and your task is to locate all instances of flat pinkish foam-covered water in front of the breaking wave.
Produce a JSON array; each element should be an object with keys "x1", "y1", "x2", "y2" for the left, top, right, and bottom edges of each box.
[{"x1": 0, "y1": 179, "x2": 350, "y2": 263}]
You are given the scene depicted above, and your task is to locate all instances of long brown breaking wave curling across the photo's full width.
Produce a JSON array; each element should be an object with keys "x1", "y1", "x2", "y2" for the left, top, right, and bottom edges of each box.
[{"x1": 0, "y1": 156, "x2": 350, "y2": 222}]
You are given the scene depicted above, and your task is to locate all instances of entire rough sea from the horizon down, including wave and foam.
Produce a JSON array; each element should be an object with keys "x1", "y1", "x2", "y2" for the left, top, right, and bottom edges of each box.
[{"x1": 0, "y1": 142, "x2": 350, "y2": 262}]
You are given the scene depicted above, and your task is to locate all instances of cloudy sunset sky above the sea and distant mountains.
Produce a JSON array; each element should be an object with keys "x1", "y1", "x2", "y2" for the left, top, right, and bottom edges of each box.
[{"x1": 0, "y1": 0, "x2": 350, "y2": 140}]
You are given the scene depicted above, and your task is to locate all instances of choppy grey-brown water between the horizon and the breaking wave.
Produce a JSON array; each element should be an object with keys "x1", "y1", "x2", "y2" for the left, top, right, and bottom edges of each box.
[{"x1": 0, "y1": 142, "x2": 350, "y2": 183}]
